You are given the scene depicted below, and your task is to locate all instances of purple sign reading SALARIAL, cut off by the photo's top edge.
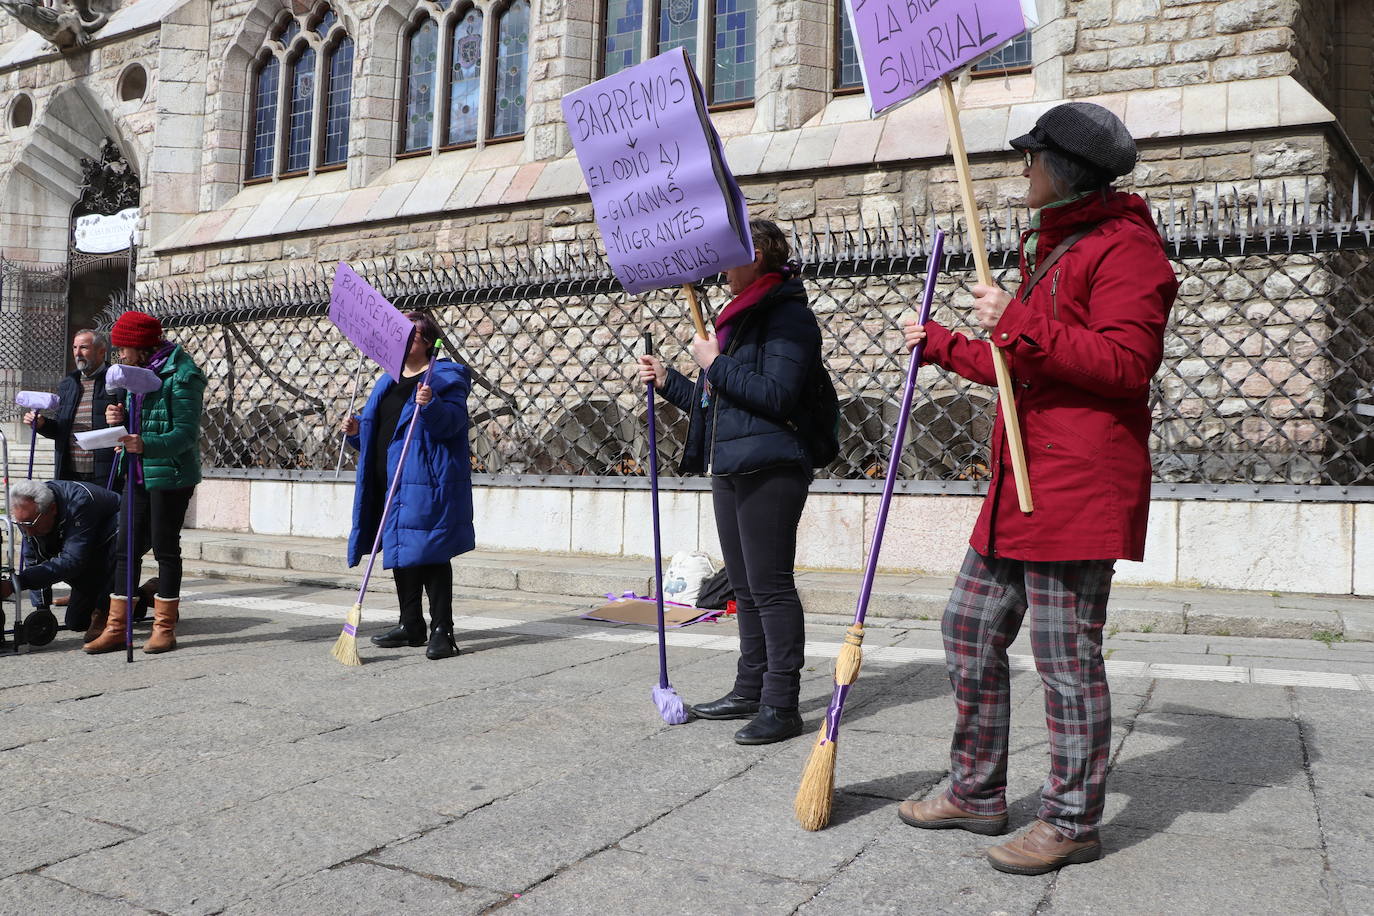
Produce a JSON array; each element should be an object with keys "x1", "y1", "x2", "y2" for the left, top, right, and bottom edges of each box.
[{"x1": 845, "y1": 0, "x2": 1036, "y2": 114}]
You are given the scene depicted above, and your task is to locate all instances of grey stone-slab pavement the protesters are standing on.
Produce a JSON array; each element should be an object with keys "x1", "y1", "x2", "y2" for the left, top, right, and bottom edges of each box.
[{"x1": 0, "y1": 580, "x2": 1374, "y2": 916}]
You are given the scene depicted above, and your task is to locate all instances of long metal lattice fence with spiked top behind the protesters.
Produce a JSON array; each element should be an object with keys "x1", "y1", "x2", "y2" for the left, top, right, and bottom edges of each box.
[{"x1": 111, "y1": 203, "x2": 1374, "y2": 486}]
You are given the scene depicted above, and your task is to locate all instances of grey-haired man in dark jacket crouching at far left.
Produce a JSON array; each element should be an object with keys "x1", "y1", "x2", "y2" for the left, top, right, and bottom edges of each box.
[{"x1": 0, "y1": 481, "x2": 120, "y2": 630}]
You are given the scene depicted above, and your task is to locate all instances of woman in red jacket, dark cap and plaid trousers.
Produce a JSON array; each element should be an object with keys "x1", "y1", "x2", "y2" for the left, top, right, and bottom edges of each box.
[{"x1": 899, "y1": 102, "x2": 1178, "y2": 875}]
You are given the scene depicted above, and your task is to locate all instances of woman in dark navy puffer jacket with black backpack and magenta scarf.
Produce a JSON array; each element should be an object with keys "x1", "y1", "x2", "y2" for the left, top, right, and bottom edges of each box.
[{"x1": 639, "y1": 220, "x2": 824, "y2": 744}]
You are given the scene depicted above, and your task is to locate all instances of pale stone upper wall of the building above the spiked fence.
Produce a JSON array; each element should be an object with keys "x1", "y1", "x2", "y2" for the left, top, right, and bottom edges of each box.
[{"x1": 0, "y1": 0, "x2": 1374, "y2": 279}]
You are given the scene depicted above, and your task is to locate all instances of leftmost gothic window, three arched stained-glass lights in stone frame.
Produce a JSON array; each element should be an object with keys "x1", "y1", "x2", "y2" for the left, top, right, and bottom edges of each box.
[{"x1": 245, "y1": 4, "x2": 353, "y2": 181}]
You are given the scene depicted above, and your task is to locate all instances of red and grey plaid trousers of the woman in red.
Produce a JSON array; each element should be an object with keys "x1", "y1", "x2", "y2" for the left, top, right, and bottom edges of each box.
[{"x1": 941, "y1": 549, "x2": 1116, "y2": 839}]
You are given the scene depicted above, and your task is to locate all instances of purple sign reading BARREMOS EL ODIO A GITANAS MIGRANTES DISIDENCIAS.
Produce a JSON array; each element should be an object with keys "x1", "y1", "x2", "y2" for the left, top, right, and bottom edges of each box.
[{"x1": 563, "y1": 48, "x2": 754, "y2": 293}]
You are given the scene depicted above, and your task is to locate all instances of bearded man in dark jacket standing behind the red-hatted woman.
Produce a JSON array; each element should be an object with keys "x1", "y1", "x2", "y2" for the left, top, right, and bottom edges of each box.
[{"x1": 23, "y1": 331, "x2": 120, "y2": 486}]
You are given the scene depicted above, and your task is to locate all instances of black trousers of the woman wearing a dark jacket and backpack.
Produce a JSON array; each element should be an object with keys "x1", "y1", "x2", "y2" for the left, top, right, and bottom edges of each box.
[{"x1": 710, "y1": 467, "x2": 811, "y2": 707}]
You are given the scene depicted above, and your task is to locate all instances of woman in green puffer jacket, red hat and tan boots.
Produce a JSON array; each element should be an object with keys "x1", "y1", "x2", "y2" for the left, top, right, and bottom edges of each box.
[{"x1": 82, "y1": 312, "x2": 205, "y2": 654}]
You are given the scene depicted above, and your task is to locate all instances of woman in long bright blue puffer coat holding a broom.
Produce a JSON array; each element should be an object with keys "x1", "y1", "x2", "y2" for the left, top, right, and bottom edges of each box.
[{"x1": 341, "y1": 312, "x2": 475, "y2": 659}]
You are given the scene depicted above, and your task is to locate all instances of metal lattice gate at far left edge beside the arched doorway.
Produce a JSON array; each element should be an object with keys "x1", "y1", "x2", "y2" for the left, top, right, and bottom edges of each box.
[{"x1": 0, "y1": 258, "x2": 67, "y2": 412}]
